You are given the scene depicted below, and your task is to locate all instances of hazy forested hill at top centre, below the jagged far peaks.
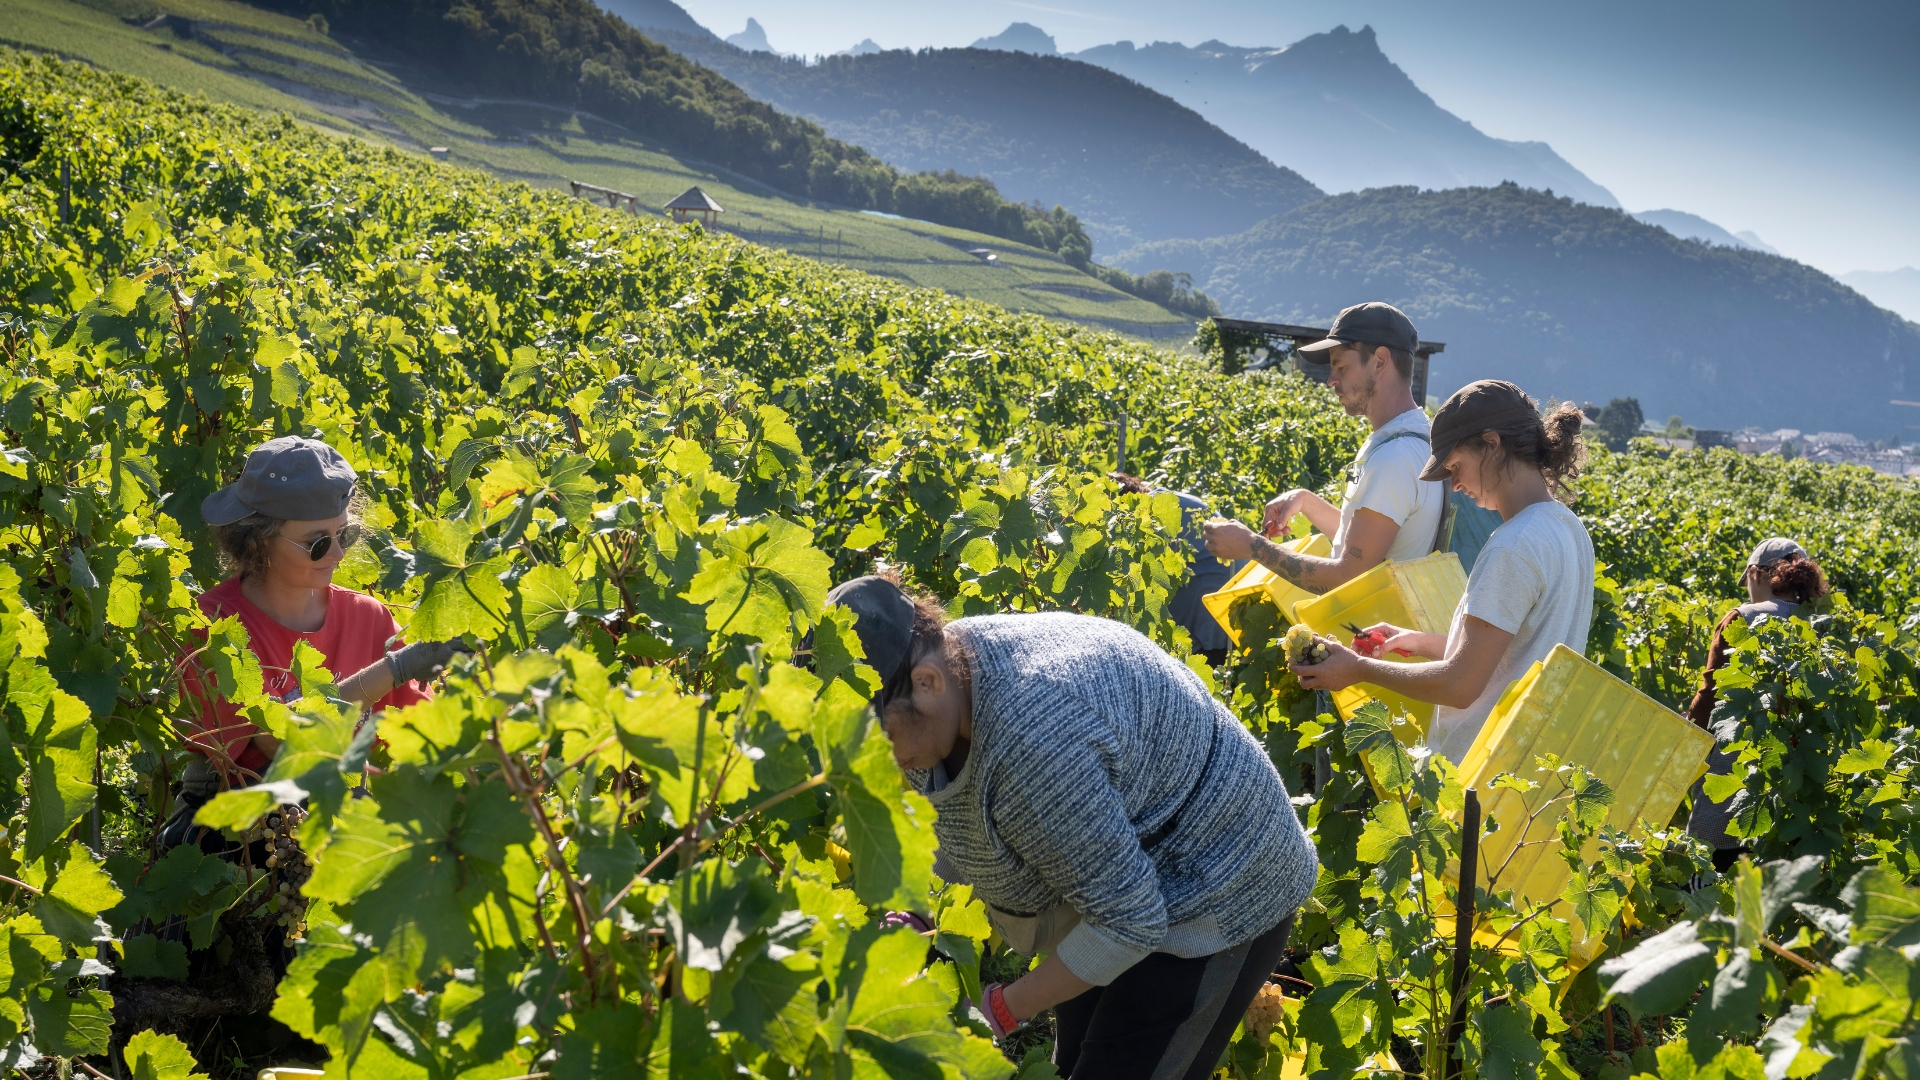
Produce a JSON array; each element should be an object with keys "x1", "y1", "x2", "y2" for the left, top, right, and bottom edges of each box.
[{"x1": 660, "y1": 33, "x2": 1321, "y2": 249}]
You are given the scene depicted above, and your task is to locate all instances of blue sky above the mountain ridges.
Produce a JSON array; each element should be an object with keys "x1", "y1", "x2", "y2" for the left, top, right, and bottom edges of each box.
[{"x1": 682, "y1": 0, "x2": 1920, "y2": 275}]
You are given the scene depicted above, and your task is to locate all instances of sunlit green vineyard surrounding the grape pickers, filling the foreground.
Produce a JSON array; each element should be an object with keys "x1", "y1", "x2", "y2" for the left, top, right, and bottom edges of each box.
[{"x1": 0, "y1": 52, "x2": 1920, "y2": 1080}]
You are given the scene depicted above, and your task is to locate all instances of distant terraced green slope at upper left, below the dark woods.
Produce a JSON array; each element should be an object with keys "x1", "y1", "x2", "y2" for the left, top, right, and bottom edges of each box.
[{"x1": 0, "y1": 0, "x2": 1192, "y2": 338}]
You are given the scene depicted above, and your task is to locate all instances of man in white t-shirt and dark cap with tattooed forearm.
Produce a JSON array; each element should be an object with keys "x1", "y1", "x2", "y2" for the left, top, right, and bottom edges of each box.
[{"x1": 1206, "y1": 302, "x2": 1446, "y2": 592}]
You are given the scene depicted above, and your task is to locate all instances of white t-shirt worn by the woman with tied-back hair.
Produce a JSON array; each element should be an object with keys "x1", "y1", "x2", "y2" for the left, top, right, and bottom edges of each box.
[{"x1": 1427, "y1": 500, "x2": 1594, "y2": 763}]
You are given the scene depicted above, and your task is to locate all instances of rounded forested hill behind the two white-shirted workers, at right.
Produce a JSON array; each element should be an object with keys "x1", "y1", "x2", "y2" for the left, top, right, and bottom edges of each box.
[{"x1": 1116, "y1": 184, "x2": 1920, "y2": 438}]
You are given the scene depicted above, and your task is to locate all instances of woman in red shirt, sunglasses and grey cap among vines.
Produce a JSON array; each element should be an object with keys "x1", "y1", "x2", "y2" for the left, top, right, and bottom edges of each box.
[{"x1": 163, "y1": 436, "x2": 455, "y2": 846}]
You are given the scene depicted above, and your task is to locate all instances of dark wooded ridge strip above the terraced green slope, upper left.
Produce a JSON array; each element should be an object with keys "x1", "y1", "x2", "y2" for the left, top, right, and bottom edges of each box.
[{"x1": 243, "y1": 0, "x2": 1091, "y2": 252}]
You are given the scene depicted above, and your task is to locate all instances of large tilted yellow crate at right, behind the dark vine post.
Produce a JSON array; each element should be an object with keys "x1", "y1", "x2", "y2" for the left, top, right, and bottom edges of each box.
[{"x1": 1448, "y1": 646, "x2": 1713, "y2": 969}]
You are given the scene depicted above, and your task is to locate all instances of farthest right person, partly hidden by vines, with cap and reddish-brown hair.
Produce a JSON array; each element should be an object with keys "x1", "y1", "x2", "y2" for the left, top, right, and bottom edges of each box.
[{"x1": 1686, "y1": 536, "x2": 1828, "y2": 874}]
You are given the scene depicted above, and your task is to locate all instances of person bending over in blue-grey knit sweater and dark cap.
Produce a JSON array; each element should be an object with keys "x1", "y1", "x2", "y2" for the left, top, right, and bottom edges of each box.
[{"x1": 828, "y1": 577, "x2": 1319, "y2": 1080}]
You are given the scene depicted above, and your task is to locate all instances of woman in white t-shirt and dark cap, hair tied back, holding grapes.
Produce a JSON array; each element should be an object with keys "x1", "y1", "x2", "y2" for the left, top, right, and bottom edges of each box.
[{"x1": 1292, "y1": 379, "x2": 1594, "y2": 765}]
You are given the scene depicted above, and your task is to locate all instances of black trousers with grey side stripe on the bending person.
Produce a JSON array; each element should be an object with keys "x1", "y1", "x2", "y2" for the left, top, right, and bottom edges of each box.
[{"x1": 1054, "y1": 915, "x2": 1294, "y2": 1080}]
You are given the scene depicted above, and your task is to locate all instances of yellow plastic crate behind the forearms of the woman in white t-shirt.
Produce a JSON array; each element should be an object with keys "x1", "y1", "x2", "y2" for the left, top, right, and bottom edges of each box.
[{"x1": 1294, "y1": 552, "x2": 1467, "y2": 744}]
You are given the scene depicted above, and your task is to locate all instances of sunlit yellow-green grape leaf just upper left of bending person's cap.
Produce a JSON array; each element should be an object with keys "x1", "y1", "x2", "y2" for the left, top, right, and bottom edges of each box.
[{"x1": 685, "y1": 515, "x2": 833, "y2": 642}]
